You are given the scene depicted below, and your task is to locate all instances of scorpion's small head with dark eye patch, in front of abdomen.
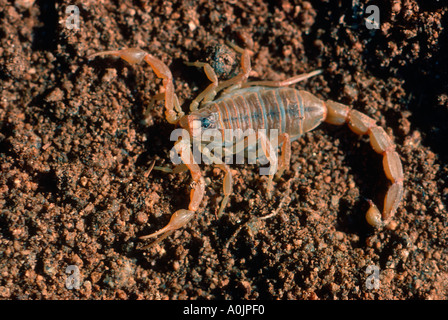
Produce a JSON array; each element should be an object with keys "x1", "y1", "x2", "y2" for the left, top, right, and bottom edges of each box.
[{"x1": 179, "y1": 109, "x2": 219, "y2": 140}]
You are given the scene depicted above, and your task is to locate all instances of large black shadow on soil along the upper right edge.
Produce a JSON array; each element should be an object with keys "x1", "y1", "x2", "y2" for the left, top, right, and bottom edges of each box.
[{"x1": 365, "y1": 4, "x2": 448, "y2": 164}]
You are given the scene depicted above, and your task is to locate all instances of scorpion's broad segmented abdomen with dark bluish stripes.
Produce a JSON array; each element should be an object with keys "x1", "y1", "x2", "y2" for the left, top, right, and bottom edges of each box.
[{"x1": 209, "y1": 87, "x2": 326, "y2": 140}]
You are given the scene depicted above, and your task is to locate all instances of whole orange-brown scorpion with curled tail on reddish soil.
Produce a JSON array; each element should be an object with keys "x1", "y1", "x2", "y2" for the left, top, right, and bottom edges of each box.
[{"x1": 88, "y1": 43, "x2": 404, "y2": 248}]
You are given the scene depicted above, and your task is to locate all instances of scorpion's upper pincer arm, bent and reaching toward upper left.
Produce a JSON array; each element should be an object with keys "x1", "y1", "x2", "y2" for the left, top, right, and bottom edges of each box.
[{"x1": 88, "y1": 48, "x2": 184, "y2": 124}]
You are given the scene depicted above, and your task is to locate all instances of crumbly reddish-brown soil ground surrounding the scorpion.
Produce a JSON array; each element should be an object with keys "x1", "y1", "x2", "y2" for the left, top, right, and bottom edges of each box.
[{"x1": 0, "y1": 0, "x2": 448, "y2": 299}]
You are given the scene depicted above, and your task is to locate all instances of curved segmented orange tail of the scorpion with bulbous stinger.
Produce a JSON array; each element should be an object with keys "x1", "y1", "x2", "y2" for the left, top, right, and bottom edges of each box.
[{"x1": 325, "y1": 100, "x2": 404, "y2": 227}]
